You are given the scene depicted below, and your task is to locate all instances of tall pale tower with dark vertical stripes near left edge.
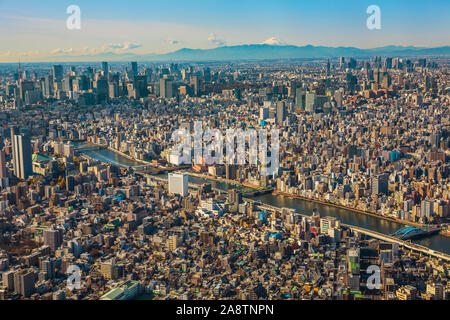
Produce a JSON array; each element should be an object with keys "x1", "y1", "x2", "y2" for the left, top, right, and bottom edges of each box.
[{"x1": 13, "y1": 134, "x2": 33, "y2": 179}]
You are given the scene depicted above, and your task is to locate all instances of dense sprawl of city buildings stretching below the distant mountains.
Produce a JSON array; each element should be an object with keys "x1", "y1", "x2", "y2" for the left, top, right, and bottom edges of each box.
[{"x1": 0, "y1": 56, "x2": 450, "y2": 300}]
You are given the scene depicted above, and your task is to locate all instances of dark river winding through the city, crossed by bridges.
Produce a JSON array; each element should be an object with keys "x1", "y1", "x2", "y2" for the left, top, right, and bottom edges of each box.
[{"x1": 76, "y1": 145, "x2": 450, "y2": 254}]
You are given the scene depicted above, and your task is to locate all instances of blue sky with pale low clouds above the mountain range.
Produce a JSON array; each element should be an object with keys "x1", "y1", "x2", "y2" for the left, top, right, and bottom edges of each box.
[{"x1": 0, "y1": 0, "x2": 450, "y2": 62}]
